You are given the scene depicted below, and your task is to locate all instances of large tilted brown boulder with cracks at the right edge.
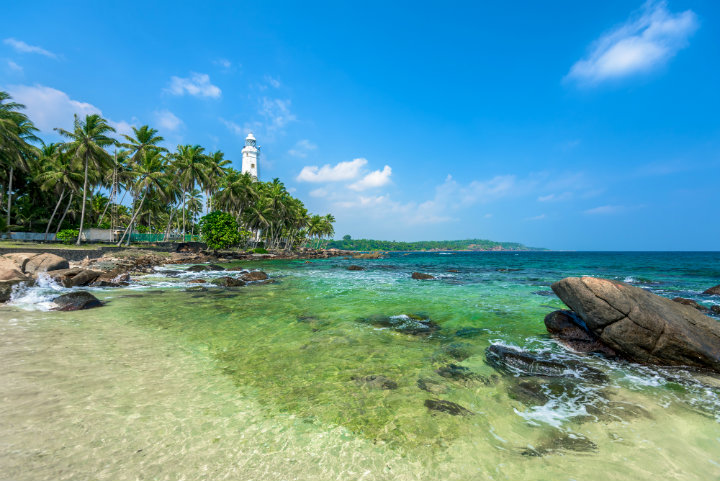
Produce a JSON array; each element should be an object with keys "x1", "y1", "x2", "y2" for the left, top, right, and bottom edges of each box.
[{"x1": 552, "y1": 277, "x2": 720, "y2": 371}]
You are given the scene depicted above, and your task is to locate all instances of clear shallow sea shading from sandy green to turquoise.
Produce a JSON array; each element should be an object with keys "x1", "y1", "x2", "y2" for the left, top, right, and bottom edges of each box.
[{"x1": 0, "y1": 252, "x2": 720, "y2": 481}]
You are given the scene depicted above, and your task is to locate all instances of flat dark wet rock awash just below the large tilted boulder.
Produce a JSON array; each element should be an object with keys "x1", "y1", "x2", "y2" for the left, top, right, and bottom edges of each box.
[{"x1": 485, "y1": 344, "x2": 607, "y2": 383}]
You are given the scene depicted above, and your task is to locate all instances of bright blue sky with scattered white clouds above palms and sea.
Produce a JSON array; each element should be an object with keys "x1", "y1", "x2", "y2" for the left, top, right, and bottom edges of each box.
[{"x1": 0, "y1": 0, "x2": 720, "y2": 250}]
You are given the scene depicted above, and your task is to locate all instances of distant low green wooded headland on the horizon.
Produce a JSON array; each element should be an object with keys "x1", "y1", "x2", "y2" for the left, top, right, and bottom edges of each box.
[{"x1": 327, "y1": 235, "x2": 544, "y2": 251}]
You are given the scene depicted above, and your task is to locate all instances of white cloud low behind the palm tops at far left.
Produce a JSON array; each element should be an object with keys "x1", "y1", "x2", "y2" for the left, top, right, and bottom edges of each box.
[{"x1": 6, "y1": 85, "x2": 132, "y2": 133}]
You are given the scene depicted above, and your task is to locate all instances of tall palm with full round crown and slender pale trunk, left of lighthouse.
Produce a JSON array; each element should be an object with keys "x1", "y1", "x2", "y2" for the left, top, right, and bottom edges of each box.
[{"x1": 55, "y1": 114, "x2": 115, "y2": 245}]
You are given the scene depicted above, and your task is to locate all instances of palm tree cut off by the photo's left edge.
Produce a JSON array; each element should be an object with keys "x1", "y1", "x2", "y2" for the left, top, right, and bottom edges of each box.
[{"x1": 0, "y1": 91, "x2": 40, "y2": 229}]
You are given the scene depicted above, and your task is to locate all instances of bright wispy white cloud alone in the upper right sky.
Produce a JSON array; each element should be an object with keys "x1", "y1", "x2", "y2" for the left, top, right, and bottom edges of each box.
[{"x1": 566, "y1": 1, "x2": 698, "y2": 84}]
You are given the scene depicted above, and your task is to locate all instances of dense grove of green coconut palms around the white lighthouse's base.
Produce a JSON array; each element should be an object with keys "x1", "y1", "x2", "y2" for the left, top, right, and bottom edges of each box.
[{"x1": 0, "y1": 91, "x2": 335, "y2": 249}]
